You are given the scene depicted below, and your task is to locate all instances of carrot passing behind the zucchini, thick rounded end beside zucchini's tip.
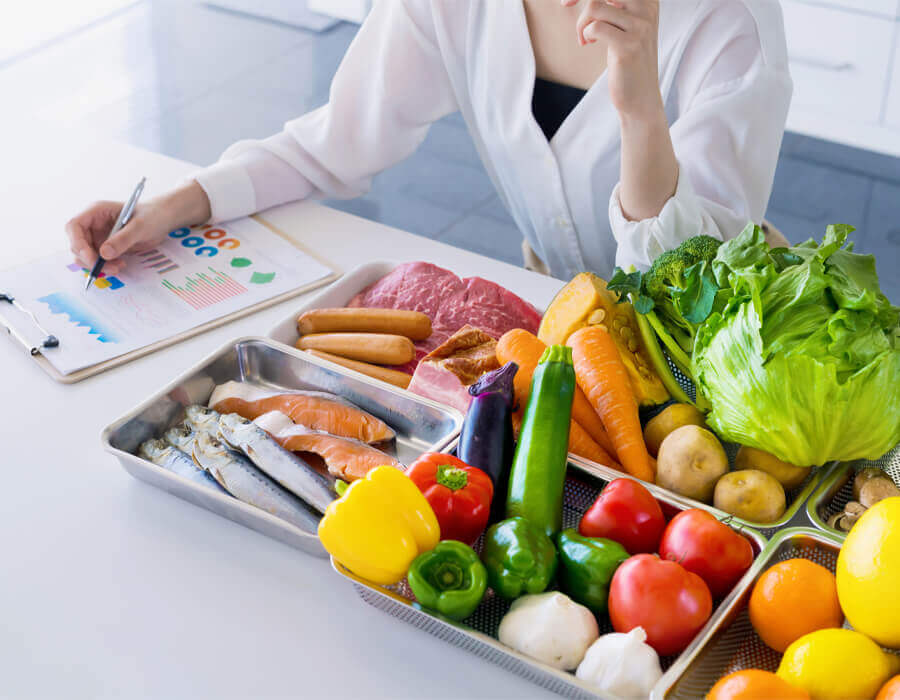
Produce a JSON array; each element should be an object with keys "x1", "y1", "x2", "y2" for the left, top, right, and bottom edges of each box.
[{"x1": 495, "y1": 328, "x2": 616, "y2": 461}]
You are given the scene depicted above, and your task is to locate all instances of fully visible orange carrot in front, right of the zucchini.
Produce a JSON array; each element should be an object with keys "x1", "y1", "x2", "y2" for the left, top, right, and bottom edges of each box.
[{"x1": 566, "y1": 326, "x2": 655, "y2": 483}]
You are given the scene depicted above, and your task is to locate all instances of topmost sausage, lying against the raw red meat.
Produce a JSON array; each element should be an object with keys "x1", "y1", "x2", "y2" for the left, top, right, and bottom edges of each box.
[{"x1": 297, "y1": 308, "x2": 431, "y2": 340}]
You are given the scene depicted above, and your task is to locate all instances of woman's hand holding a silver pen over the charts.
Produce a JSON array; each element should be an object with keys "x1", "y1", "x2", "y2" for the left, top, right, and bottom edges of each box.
[{"x1": 66, "y1": 182, "x2": 210, "y2": 275}]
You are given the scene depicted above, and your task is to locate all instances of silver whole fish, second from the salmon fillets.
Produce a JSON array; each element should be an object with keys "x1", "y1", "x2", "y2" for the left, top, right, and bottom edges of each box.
[{"x1": 194, "y1": 432, "x2": 322, "y2": 534}]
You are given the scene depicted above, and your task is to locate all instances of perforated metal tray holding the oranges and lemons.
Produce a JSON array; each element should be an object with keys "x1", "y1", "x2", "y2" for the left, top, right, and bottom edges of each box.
[{"x1": 651, "y1": 528, "x2": 868, "y2": 700}]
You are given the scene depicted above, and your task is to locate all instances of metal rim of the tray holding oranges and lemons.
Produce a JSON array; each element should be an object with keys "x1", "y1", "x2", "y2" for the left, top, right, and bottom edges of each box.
[{"x1": 650, "y1": 527, "x2": 843, "y2": 700}]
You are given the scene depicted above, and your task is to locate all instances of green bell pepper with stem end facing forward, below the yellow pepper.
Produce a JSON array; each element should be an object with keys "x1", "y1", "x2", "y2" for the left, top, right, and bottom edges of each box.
[{"x1": 406, "y1": 540, "x2": 487, "y2": 620}]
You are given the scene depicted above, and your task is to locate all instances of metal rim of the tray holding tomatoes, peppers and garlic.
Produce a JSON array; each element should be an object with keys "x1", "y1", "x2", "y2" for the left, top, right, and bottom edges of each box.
[{"x1": 331, "y1": 454, "x2": 770, "y2": 697}]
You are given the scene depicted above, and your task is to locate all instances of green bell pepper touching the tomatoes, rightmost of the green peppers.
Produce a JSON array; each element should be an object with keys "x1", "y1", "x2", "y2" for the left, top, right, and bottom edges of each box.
[{"x1": 557, "y1": 528, "x2": 631, "y2": 615}]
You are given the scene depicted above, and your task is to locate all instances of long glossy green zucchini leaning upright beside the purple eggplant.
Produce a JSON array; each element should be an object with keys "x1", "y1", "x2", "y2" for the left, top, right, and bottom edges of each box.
[{"x1": 506, "y1": 345, "x2": 575, "y2": 537}]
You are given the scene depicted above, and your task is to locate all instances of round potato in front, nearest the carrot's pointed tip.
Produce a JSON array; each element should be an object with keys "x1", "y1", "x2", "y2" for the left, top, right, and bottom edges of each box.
[{"x1": 656, "y1": 425, "x2": 728, "y2": 503}]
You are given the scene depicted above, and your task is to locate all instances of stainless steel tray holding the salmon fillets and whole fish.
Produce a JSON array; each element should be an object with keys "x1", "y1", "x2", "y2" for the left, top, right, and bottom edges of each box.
[{"x1": 101, "y1": 338, "x2": 462, "y2": 557}]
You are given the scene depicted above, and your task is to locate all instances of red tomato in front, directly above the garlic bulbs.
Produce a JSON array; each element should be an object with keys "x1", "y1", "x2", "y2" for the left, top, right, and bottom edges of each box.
[{"x1": 609, "y1": 554, "x2": 712, "y2": 656}]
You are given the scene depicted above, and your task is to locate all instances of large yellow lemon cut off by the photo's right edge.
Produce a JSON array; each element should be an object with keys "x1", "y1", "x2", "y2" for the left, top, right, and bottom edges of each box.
[{"x1": 837, "y1": 497, "x2": 900, "y2": 649}]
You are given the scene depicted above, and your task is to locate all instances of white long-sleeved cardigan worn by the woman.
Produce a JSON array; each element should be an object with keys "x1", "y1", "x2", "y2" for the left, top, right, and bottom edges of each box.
[{"x1": 195, "y1": 0, "x2": 792, "y2": 278}]
